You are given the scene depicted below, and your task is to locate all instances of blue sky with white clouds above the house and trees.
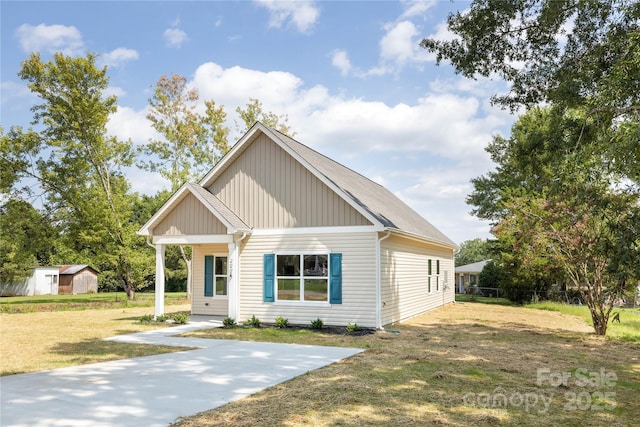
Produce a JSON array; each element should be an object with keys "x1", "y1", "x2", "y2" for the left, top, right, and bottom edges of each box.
[{"x1": 0, "y1": 0, "x2": 516, "y2": 244}]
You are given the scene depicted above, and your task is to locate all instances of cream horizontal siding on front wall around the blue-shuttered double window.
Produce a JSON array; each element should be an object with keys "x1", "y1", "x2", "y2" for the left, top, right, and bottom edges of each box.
[{"x1": 236, "y1": 232, "x2": 377, "y2": 327}]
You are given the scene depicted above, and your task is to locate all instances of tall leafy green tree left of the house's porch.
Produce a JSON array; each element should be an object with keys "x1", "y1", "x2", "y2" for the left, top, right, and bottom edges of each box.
[{"x1": 1, "y1": 53, "x2": 145, "y2": 298}]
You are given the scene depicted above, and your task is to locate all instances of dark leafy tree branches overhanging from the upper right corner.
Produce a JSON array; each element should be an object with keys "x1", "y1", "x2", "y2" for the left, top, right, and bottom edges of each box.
[{"x1": 421, "y1": 0, "x2": 640, "y2": 117}]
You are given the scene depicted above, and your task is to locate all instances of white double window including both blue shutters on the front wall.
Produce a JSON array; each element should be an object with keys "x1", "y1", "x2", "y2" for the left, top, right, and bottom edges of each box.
[{"x1": 263, "y1": 253, "x2": 342, "y2": 304}]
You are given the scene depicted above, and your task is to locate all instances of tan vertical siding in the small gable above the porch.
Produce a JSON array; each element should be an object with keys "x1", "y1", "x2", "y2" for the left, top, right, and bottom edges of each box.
[{"x1": 153, "y1": 194, "x2": 227, "y2": 236}]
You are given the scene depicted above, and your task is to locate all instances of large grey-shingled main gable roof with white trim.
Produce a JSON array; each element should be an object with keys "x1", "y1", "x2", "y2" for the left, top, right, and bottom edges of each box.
[{"x1": 200, "y1": 122, "x2": 457, "y2": 248}]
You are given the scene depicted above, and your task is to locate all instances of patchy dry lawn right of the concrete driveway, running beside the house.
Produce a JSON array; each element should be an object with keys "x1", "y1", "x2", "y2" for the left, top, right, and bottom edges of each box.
[{"x1": 175, "y1": 303, "x2": 640, "y2": 427}]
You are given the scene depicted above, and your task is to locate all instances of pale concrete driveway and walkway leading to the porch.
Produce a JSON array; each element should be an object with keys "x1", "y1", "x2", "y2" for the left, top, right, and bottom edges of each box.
[{"x1": 0, "y1": 317, "x2": 362, "y2": 427}]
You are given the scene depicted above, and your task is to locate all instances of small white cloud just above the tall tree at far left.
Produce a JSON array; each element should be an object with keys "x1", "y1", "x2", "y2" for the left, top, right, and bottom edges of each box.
[{"x1": 15, "y1": 24, "x2": 84, "y2": 56}]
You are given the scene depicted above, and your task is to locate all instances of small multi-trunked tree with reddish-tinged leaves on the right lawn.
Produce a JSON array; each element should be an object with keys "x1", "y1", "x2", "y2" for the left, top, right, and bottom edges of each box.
[{"x1": 495, "y1": 180, "x2": 640, "y2": 335}]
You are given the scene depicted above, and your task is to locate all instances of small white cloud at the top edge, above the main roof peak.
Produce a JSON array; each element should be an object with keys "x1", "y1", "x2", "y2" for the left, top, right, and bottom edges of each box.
[{"x1": 256, "y1": 0, "x2": 320, "y2": 33}]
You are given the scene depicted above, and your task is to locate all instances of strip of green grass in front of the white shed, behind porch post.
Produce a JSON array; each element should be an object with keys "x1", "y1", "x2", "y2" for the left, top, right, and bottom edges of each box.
[{"x1": 0, "y1": 292, "x2": 188, "y2": 313}]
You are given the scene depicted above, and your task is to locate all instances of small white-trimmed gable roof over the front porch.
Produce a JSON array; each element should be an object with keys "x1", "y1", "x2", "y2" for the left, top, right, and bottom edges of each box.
[{"x1": 138, "y1": 182, "x2": 251, "y2": 236}]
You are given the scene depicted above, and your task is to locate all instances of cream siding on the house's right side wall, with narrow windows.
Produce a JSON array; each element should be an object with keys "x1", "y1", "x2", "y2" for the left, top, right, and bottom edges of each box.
[{"x1": 380, "y1": 236, "x2": 455, "y2": 325}]
